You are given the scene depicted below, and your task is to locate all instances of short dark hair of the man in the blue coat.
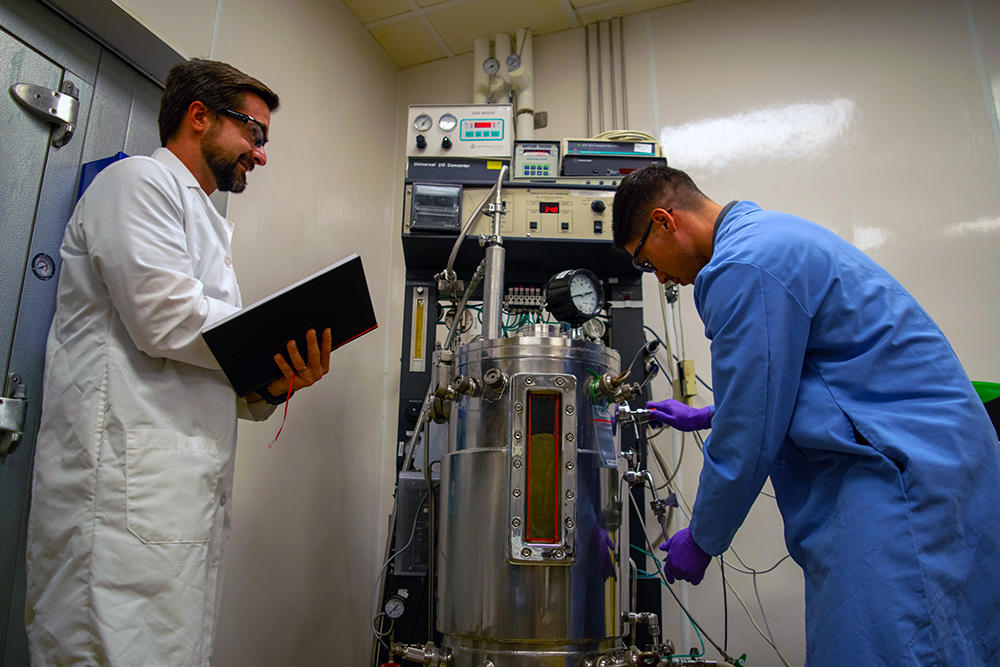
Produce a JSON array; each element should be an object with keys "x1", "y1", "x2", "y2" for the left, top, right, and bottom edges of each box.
[{"x1": 611, "y1": 165, "x2": 706, "y2": 252}]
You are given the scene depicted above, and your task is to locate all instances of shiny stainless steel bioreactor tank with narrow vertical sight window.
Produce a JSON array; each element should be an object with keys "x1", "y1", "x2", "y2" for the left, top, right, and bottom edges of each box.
[{"x1": 438, "y1": 325, "x2": 627, "y2": 667}]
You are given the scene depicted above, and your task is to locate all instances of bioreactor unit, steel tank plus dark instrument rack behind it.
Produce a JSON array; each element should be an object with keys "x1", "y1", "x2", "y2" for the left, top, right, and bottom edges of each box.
[{"x1": 380, "y1": 140, "x2": 673, "y2": 667}]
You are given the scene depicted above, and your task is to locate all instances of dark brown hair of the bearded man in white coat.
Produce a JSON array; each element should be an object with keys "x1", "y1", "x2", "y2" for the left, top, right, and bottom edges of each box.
[{"x1": 159, "y1": 59, "x2": 278, "y2": 146}]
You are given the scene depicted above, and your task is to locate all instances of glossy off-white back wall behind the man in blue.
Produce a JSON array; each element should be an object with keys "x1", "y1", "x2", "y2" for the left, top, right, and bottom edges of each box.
[{"x1": 400, "y1": 0, "x2": 1000, "y2": 665}]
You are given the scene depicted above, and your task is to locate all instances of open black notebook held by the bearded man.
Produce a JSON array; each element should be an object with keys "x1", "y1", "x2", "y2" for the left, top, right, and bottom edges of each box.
[{"x1": 201, "y1": 255, "x2": 378, "y2": 396}]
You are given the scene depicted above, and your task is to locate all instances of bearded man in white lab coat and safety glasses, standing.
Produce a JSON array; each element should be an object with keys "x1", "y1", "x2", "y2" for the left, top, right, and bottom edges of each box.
[{"x1": 27, "y1": 60, "x2": 330, "y2": 667}]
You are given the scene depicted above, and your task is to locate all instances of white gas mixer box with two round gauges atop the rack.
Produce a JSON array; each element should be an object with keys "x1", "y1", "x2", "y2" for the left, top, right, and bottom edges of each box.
[{"x1": 406, "y1": 104, "x2": 514, "y2": 159}]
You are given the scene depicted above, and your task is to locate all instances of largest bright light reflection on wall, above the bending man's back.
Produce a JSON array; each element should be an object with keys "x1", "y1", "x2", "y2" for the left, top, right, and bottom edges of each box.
[{"x1": 660, "y1": 99, "x2": 854, "y2": 170}]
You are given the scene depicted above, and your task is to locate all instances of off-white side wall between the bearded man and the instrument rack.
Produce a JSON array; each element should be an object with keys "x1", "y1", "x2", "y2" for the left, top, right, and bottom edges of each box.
[{"x1": 213, "y1": 0, "x2": 398, "y2": 667}]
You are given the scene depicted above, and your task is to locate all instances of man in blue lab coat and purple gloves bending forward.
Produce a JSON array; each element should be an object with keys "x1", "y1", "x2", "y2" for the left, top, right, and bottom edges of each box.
[{"x1": 613, "y1": 166, "x2": 1000, "y2": 667}]
